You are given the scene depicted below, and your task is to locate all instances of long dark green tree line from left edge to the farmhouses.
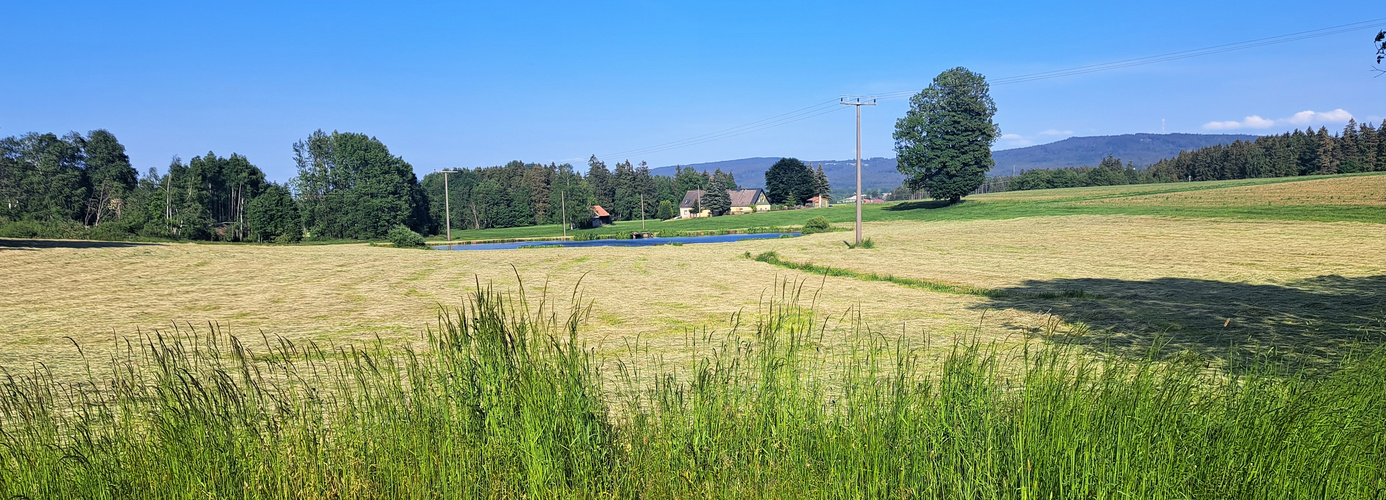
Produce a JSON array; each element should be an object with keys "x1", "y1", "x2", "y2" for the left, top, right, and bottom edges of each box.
[{"x1": 0, "y1": 130, "x2": 781, "y2": 242}]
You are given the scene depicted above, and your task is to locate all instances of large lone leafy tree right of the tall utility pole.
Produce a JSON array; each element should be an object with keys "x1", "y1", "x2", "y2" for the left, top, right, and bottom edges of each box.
[{"x1": 894, "y1": 66, "x2": 1001, "y2": 204}]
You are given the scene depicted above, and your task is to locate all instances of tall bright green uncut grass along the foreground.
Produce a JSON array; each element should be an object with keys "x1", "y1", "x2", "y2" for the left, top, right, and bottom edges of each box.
[{"x1": 0, "y1": 279, "x2": 1386, "y2": 499}]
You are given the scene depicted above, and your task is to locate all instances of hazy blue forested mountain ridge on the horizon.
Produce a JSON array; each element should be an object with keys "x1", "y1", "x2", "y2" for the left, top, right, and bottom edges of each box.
[{"x1": 650, "y1": 133, "x2": 1257, "y2": 190}]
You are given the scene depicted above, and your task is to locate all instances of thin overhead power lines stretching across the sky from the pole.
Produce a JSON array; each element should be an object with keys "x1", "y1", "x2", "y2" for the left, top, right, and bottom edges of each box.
[{"x1": 600, "y1": 18, "x2": 1386, "y2": 158}]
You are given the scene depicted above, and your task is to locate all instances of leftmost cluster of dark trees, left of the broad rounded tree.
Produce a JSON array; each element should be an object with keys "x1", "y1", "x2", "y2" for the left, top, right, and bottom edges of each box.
[{"x1": 0, "y1": 130, "x2": 292, "y2": 240}]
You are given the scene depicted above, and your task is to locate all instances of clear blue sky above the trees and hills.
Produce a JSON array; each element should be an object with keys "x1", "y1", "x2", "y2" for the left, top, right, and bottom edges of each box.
[{"x1": 0, "y1": 1, "x2": 1386, "y2": 181}]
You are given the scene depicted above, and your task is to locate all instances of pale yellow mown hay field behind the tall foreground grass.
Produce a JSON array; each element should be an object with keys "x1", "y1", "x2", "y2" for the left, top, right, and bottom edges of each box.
[{"x1": 0, "y1": 176, "x2": 1386, "y2": 366}]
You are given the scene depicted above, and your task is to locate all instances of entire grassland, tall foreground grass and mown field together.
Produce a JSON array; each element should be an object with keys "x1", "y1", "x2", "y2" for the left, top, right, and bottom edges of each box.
[{"x1": 0, "y1": 171, "x2": 1386, "y2": 499}]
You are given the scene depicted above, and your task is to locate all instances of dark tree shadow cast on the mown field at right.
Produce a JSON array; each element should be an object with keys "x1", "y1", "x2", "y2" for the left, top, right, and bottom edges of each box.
[{"x1": 976, "y1": 276, "x2": 1386, "y2": 368}]
